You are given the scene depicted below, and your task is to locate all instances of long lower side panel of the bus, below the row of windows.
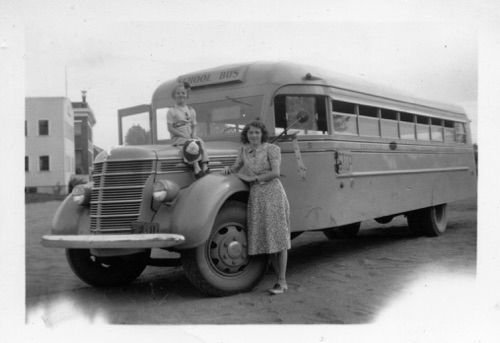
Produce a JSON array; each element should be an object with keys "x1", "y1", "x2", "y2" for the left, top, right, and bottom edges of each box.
[{"x1": 281, "y1": 138, "x2": 476, "y2": 231}]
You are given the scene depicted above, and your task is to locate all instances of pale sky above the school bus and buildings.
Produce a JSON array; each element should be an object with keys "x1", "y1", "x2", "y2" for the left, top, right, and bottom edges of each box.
[{"x1": 21, "y1": 1, "x2": 478, "y2": 149}]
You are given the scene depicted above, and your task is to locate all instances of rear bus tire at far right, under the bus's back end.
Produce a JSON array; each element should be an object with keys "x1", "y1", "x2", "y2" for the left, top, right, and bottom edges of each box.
[{"x1": 407, "y1": 204, "x2": 448, "y2": 237}]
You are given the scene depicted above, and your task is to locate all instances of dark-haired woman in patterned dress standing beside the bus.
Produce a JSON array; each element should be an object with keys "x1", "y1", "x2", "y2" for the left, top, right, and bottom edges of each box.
[{"x1": 222, "y1": 121, "x2": 291, "y2": 294}]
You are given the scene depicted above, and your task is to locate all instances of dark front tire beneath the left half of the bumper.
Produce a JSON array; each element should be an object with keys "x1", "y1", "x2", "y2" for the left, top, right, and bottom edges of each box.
[{"x1": 66, "y1": 249, "x2": 149, "y2": 287}]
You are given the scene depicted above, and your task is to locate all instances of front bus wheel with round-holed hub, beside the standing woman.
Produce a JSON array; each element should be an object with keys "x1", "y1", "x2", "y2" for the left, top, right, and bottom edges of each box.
[{"x1": 181, "y1": 201, "x2": 268, "y2": 297}]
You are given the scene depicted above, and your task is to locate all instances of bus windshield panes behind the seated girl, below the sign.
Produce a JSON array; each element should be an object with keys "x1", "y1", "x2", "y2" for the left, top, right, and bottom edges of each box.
[{"x1": 156, "y1": 95, "x2": 262, "y2": 143}]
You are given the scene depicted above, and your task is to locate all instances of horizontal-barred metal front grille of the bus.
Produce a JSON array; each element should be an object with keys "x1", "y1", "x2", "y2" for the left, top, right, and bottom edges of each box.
[{"x1": 90, "y1": 160, "x2": 155, "y2": 233}]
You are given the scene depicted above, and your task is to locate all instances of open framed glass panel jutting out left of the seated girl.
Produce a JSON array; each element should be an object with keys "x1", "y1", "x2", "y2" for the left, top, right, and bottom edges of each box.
[{"x1": 118, "y1": 105, "x2": 153, "y2": 145}]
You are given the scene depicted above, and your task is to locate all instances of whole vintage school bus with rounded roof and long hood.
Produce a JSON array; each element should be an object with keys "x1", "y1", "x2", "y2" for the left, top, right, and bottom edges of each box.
[{"x1": 42, "y1": 62, "x2": 476, "y2": 296}]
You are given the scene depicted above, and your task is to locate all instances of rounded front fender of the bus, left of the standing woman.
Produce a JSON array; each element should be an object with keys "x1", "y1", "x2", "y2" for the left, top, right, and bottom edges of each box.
[{"x1": 158, "y1": 174, "x2": 249, "y2": 249}]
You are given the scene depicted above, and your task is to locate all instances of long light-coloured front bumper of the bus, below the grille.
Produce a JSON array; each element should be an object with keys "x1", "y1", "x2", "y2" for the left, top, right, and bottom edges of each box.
[{"x1": 41, "y1": 233, "x2": 185, "y2": 249}]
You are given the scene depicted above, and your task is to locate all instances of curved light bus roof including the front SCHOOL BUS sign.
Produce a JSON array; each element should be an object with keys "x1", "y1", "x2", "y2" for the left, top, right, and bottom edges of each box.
[{"x1": 152, "y1": 61, "x2": 465, "y2": 115}]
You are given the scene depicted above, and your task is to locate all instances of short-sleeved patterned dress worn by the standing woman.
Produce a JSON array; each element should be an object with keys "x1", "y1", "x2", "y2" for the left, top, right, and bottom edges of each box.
[{"x1": 234, "y1": 143, "x2": 291, "y2": 255}]
